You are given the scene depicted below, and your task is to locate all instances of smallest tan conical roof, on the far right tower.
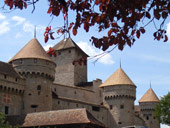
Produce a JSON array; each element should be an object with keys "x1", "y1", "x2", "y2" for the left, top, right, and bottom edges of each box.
[{"x1": 139, "y1": 88, "x2": 159, "y2": 103}]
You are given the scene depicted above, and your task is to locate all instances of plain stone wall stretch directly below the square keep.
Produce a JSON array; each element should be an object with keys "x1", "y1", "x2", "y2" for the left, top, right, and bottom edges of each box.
[{"x1": 52, "y1": 80, "x2": 102, "y2": 105}]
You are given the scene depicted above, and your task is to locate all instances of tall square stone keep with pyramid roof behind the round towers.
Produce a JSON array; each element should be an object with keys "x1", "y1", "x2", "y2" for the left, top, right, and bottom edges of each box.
[{"x1": 51, "y1": 38, "x2": 88, "y2": 86}]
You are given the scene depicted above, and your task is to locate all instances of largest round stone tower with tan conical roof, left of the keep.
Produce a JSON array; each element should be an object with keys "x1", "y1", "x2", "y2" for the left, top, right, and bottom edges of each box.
[{"x1": 9, "y1": 38, "x2": 55, "y2": 114}]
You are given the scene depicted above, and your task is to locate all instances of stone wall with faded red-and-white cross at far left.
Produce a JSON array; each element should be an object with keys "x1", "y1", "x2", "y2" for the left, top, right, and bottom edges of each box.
[{"x1": 0, "y1": 74, "x2": 25, "y2": 115}]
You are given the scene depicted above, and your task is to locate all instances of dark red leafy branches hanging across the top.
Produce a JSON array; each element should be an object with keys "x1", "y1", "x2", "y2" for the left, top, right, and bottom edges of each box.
[{"x1": 3, "y1": 0, "x2": 170, "y2": 51}]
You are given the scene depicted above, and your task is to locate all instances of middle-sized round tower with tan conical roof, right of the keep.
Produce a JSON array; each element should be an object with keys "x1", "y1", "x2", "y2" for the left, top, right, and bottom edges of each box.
[{"x1": 100, "y1": 68, "x2": 136, "y2": 128}]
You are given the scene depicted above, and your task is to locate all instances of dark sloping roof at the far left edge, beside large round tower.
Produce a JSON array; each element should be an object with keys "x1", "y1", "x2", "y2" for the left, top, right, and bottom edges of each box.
[{"x1": 0, "y1": 61, "x2": 20, "y2": 77}]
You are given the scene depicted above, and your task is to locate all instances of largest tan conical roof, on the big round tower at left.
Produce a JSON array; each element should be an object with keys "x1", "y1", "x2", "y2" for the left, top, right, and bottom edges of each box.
[{"x1": 9, "y1": 38, "x2": 52, "y2": 62}]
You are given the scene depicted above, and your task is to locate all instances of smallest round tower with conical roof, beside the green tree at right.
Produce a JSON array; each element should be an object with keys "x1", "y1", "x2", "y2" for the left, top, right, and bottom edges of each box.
[{"x1": 139, "y1": 88, "x2": 160, "y2": 128}]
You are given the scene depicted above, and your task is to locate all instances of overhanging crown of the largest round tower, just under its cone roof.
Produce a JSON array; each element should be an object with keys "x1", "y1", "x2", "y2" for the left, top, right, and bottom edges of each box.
[{"x1": 12, "y1": 58, "x2": 55, "y2": 80}]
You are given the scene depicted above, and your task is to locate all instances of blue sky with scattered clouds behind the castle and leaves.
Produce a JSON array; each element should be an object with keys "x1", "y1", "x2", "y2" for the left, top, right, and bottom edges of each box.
[{"x1": 0, "y1": 0, "x2": 170, "y2": 128}]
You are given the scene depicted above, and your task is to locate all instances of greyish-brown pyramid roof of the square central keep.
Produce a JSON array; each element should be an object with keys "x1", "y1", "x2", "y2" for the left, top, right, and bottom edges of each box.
[{"x1": 53, "y1": 38, "x2": 88, "y2": 56}]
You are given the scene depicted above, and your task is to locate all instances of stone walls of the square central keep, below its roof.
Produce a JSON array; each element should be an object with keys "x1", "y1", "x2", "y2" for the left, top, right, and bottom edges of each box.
[{"x1": 51, "y1": 48, "x2": 87, "y2": 86}]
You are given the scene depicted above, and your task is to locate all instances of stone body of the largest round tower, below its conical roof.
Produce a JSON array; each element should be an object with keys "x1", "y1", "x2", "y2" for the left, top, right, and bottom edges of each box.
[{"x1": 12, "y1": 59, "x2": 55, "y2": 114}]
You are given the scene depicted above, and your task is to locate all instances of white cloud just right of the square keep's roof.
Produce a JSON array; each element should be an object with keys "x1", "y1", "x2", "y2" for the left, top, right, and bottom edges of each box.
[{"x1": 78, "y1": 42, "x2": 114, "y2": 64}]
